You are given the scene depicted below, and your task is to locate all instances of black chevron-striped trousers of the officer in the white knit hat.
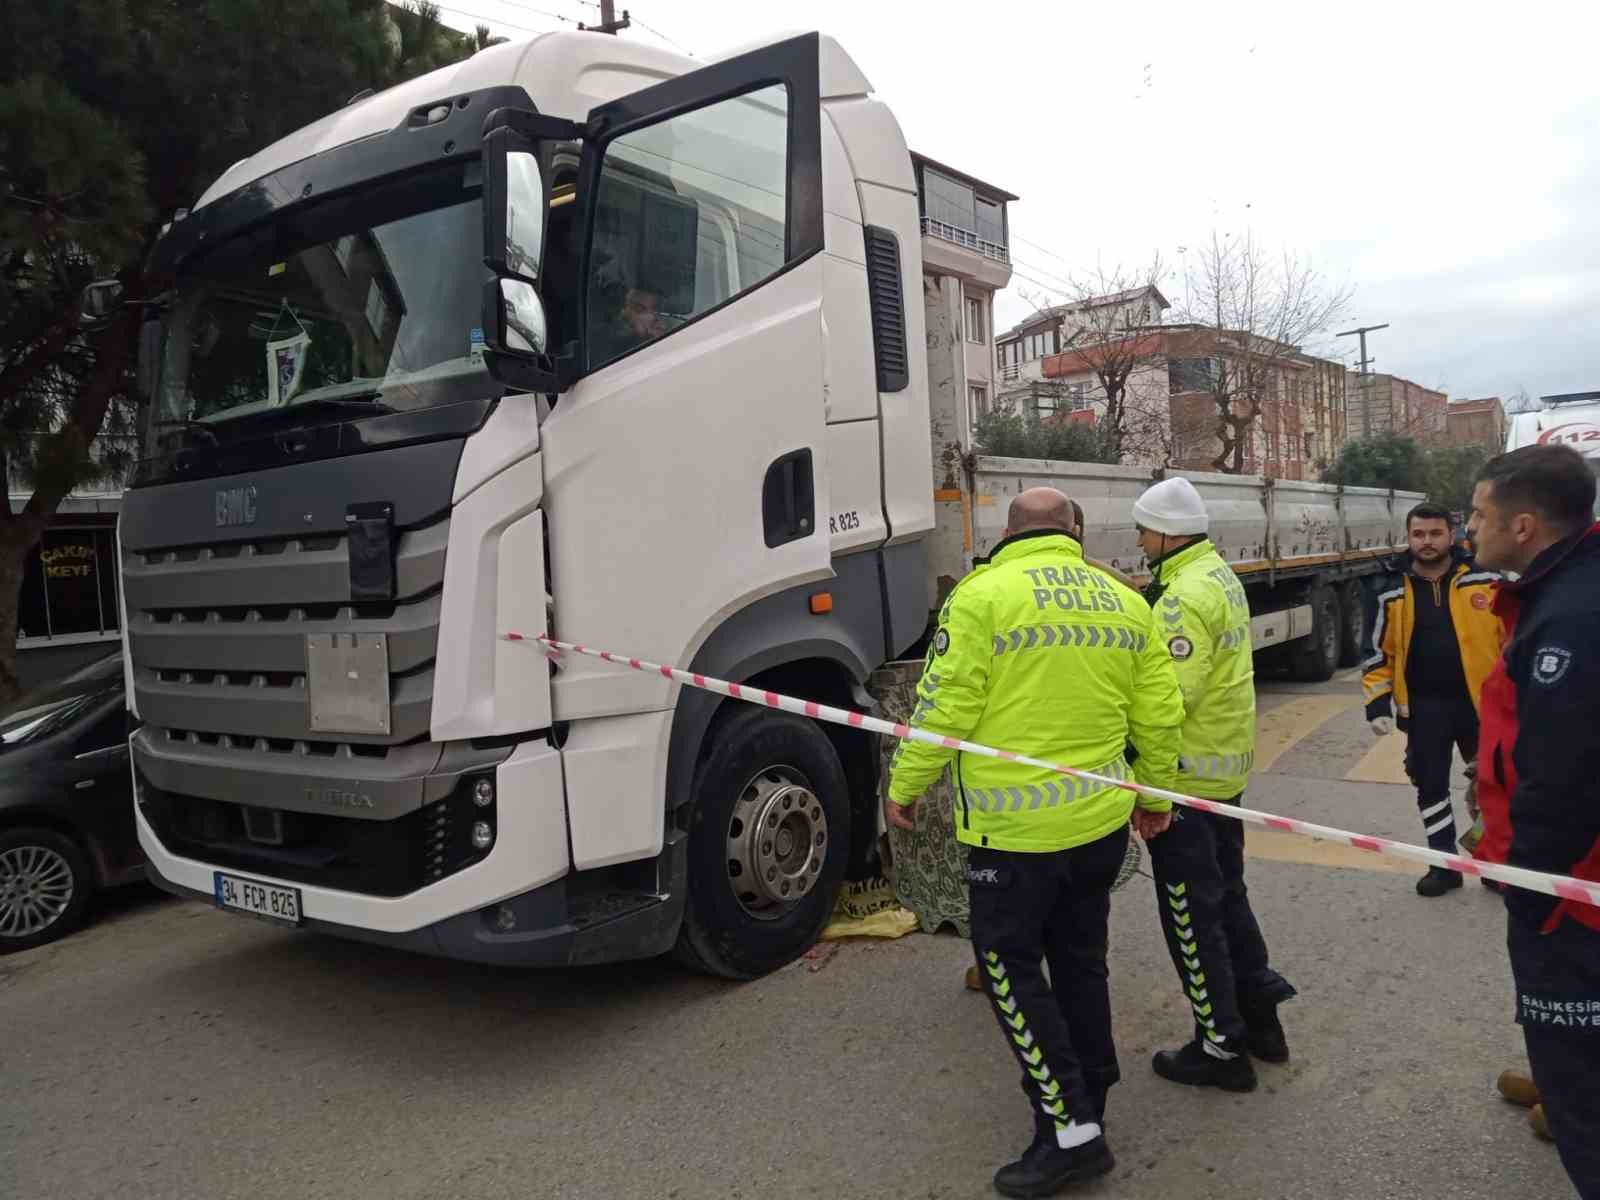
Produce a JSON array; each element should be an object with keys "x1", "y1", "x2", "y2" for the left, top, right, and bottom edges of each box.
[{"x1": 1149, "y1": 797, "x2": 1293, "y2": 1053}]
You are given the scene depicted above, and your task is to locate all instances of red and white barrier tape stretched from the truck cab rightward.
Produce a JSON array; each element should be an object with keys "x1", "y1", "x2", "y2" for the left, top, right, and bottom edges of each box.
[{"x1": 504, "y1": 634, "x2": 1600, "y2": 907}]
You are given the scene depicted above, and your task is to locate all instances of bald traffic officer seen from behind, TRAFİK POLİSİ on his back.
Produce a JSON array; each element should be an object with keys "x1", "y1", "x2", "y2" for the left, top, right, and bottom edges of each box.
[{"x1": 885, "y1": 488, "x2": 1182, "y2": 1195}]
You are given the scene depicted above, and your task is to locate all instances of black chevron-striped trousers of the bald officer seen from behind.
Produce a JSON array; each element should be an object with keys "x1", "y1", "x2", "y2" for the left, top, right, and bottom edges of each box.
[{"x1": 966, "y1": 827, "x2": 1128, "y2": 1131}]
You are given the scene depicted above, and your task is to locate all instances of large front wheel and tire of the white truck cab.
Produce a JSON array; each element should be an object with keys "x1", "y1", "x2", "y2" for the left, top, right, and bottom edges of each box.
[{"x1": 674, "y1": 706, "x2": 850, "y2": 979}]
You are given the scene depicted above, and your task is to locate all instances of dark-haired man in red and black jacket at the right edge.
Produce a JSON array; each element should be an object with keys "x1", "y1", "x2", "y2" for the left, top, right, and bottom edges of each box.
[{"x1": 1470, "y1": 445, "x2": 1600, "y2": 1200}]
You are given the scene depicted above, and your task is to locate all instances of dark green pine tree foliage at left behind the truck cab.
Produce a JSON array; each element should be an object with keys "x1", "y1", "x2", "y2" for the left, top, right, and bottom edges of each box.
[{"x1": 0, "y1": 0, "x2": 488, "y2": 698}]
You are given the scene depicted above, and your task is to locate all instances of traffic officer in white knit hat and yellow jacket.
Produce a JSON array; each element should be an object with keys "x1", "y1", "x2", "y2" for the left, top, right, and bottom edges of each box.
[{"x1": 1133, "y1": 478, "x2": 1294, "y2": 1091}]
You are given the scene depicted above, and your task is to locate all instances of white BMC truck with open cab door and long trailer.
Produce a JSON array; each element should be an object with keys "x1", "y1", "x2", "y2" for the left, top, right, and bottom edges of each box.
[{"x1": 120, "y1": 34, "x2": 1403, "y2": 978}]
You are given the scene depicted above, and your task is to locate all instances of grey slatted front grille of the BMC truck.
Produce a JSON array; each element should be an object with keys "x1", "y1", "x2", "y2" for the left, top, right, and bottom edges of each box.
[{"x1": 123, "y1": 520, "x2": 450, "y2": 754}]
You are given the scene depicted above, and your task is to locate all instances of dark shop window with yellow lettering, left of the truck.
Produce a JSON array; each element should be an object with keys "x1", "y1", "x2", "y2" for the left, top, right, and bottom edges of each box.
[{"x1": 16, "y1": 526, "x2": 122, "y2": 642}]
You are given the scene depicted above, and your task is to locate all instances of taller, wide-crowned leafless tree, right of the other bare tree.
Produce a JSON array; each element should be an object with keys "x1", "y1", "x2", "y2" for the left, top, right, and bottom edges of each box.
[{"x1": 1173, "y1": 232, "x2": 1352, "y2": 475}]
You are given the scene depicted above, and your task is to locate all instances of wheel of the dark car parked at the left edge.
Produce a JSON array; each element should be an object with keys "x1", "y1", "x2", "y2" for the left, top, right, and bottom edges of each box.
[{"x1": 0, "y1": 827, "x2": 94, "y2": 954}]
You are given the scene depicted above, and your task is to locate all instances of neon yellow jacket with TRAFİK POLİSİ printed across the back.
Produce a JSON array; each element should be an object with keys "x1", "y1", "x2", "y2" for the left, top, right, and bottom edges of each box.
[{"x1": 888, "y1": 531, "x2": 1184, "y2": 853}]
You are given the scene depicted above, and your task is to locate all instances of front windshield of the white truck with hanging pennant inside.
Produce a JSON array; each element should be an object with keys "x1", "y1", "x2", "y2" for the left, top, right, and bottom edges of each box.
[{"x1": 150, "y1": 162, "x2": 488, "y2": 453}]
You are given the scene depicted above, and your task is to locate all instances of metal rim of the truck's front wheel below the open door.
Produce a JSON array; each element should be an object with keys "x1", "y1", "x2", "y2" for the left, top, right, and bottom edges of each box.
[{"x1": 728, "y1": 766, "x2": 827, "y2": 920}]
